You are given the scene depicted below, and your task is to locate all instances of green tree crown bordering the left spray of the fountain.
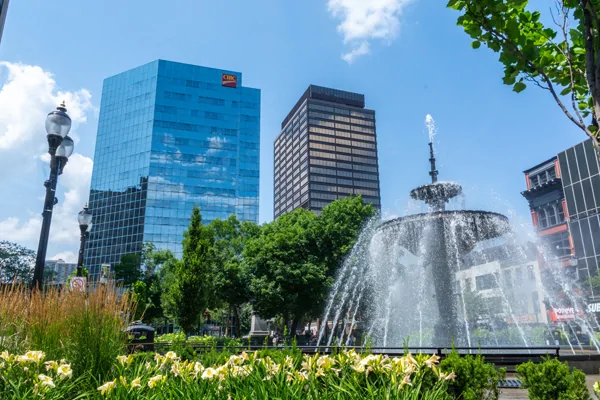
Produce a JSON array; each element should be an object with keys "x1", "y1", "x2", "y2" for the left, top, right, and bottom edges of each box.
[{"x1": 317, "y1": 196, "x2": 377, "y2": 276}]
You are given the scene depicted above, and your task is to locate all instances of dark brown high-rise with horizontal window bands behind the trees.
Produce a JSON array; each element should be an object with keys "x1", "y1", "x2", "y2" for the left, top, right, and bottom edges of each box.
[{"x1": 273, "y1": 85, "x2": 381, "y2": 218}]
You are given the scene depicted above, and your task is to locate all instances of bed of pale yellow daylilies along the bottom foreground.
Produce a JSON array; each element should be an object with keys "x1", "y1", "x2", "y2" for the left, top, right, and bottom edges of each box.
[{"x1": 0, "y1": 351, "x2": 455, "y2": 400}]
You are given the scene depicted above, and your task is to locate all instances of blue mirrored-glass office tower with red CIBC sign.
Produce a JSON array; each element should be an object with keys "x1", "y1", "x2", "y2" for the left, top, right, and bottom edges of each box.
[{"x1": 85, "y1": 60, "x2": 260, "y2": 274}]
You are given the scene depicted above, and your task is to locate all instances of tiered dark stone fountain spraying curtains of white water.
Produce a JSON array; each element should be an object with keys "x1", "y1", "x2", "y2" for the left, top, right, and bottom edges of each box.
[{"x1": 318, "y1": 115, "x2": 595, "y2": 347}]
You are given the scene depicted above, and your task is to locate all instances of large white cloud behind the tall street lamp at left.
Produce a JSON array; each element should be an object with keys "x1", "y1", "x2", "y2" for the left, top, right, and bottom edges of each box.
[{"x1": 0, "y1": 62, "x2": 94, "y2": 255}]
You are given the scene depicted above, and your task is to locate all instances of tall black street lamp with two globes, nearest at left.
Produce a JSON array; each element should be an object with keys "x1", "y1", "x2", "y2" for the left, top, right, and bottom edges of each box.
[{"x1": 32, "y1": 101, "x2": 74, "y2": 289}]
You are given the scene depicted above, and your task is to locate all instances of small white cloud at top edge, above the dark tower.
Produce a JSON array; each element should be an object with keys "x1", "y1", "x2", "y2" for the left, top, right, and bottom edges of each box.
[{"x1": 327, "y1": 0, "x2": 412, "y2": 63}]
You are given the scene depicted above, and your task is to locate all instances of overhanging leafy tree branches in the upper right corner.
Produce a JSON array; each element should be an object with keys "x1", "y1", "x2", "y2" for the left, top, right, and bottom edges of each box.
[{"x1": 447, "y1": 0, "x2": 600, "y2": 149}]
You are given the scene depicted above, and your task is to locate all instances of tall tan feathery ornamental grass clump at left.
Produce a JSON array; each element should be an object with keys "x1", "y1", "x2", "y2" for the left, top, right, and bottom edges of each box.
[{"x1": 0, "y1": 285, "x2": 135, "y2": 382}]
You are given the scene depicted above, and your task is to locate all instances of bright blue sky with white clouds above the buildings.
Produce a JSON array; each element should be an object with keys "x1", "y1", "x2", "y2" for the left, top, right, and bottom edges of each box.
[{"x1": 0, "y1": 0, "x2": 585, "y2": 261}]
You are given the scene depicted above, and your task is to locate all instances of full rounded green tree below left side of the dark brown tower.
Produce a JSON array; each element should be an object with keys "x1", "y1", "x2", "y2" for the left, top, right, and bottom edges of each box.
[{"x1": 243, "y1": 208, "x2": 332, "y2": 334}]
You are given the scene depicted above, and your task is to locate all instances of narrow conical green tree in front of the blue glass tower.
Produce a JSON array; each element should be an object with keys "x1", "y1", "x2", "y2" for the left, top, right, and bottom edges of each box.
[{"x1": 166, "y1": 207, "x2": 214, "y2": 334}]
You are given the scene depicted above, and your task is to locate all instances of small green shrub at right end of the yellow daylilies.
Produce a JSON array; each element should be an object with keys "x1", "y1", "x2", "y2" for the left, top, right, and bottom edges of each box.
[{"x1": 440, "y1": 351, "x2": 506, "y2": 400}]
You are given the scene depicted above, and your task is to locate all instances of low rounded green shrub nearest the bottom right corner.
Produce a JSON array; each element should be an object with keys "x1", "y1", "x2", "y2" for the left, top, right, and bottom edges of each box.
[{"x1": 517, "y1": 358, "x2": 591, "y2": 400}]
